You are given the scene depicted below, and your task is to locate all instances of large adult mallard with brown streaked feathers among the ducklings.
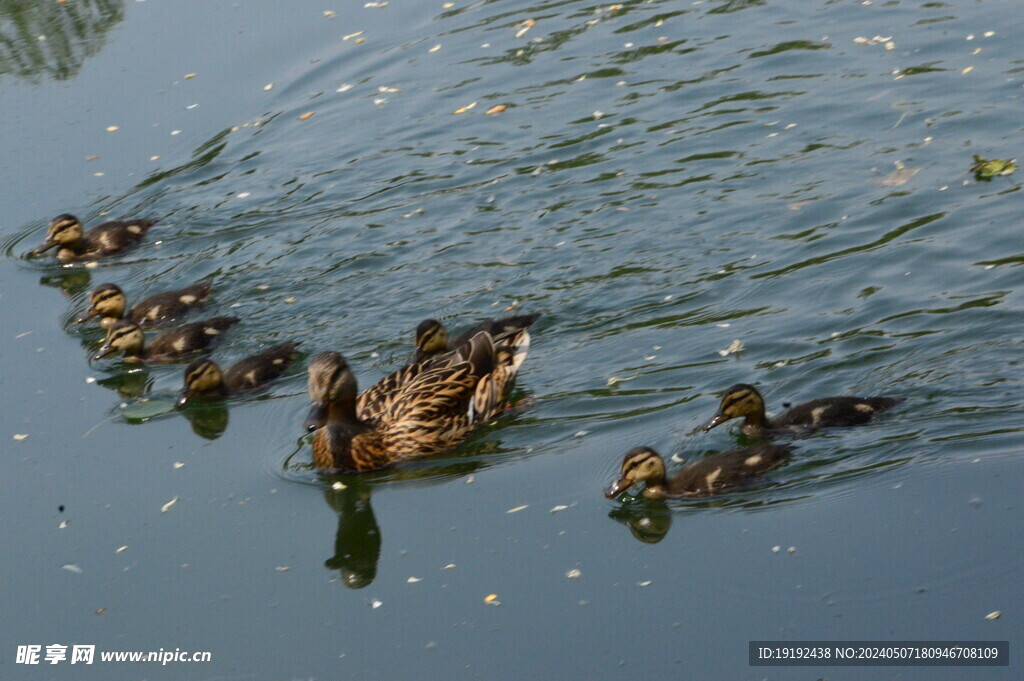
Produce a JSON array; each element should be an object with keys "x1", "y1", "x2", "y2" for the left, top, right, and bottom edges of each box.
[{"x1": 309, "y1": 329, "x2": 529, "y2": 471}]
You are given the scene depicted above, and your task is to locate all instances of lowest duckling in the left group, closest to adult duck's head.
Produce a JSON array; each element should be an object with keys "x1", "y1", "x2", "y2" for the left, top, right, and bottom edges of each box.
[{"x1": 177, "y1": 343, "x2": 298, "y2": 407}]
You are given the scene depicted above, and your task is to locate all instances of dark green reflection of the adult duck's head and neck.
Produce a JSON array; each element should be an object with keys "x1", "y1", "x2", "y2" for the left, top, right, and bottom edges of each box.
[{"x1": 324, "y1": 476, "x2": 381, "y2": 589}]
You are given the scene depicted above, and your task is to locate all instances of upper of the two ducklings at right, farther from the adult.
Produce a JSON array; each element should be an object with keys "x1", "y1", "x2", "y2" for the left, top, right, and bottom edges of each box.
[{"x1": 700, "y1": 383, "x2": 902, "y2": 438}]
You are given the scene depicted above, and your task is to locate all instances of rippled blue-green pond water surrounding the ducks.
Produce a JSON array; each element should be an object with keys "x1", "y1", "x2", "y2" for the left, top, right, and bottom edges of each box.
[{"x1": 0, "y1": 0, "x2": 1024, "y2": 681}]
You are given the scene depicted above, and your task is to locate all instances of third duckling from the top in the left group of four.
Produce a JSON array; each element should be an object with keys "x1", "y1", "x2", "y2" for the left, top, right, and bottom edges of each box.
[{"x1": 92, "y1": 316, "x2": 239, "y2": 361}]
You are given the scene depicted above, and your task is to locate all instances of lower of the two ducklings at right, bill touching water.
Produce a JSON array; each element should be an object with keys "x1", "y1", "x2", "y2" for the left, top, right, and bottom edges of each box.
[{"x1": 604, "y1": 444, "x2": 793, "y2": 499}]
